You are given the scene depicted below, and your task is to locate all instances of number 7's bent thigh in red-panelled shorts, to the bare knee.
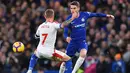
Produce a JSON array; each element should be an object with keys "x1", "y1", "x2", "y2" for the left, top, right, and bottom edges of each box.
[{"x1": 53, "y1": 50, "x2": 70, "y2": 61}]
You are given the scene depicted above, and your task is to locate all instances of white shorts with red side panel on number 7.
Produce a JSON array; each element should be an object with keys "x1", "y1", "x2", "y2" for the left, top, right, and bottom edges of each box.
[{"x1": 34, "y1": 47, "x2": 65, "y2": 60}]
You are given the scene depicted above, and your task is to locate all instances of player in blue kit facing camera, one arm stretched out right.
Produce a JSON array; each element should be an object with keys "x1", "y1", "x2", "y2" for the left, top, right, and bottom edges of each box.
[{"x1": 59, "y1": 1, "x2": 114, "y2": 73}]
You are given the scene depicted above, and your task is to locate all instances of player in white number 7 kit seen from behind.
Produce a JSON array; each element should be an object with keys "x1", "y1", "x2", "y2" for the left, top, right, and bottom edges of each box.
[{"x1": 27, "y1": 9, "x2": 77, "y2": 73}]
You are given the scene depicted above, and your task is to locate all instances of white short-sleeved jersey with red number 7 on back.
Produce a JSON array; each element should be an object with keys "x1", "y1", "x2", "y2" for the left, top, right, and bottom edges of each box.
[{"x1": 36, "y1": 22, "x2": 60, "y2": 49}]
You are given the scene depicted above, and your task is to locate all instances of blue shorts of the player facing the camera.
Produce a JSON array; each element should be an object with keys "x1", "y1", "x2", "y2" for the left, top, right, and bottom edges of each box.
[{"x1": 66, "y1": 40, "x2": 88, "y2": 56}]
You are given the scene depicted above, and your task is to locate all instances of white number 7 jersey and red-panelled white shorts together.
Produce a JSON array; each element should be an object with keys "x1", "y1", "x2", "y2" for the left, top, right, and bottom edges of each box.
[{"x1": 35, "y1": 22, "x2": 65, "y2": 60}]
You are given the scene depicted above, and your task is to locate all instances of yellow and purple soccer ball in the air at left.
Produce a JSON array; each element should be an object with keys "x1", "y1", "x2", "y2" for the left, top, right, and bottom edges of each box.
[{"x1": 13, "y1": 42, "x2": 24, "y2": 53}]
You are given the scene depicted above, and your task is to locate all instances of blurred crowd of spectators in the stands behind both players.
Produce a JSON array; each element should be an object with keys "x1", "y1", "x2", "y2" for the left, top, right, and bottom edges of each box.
[{"x1": 0, "y1": 0, "x2": 130, "y2": 73}]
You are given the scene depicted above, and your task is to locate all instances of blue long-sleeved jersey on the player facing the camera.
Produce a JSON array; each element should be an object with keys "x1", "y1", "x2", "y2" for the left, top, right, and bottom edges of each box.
[{"x1": 64, "y1": 12, "x2": 106, "y2": 40}]
